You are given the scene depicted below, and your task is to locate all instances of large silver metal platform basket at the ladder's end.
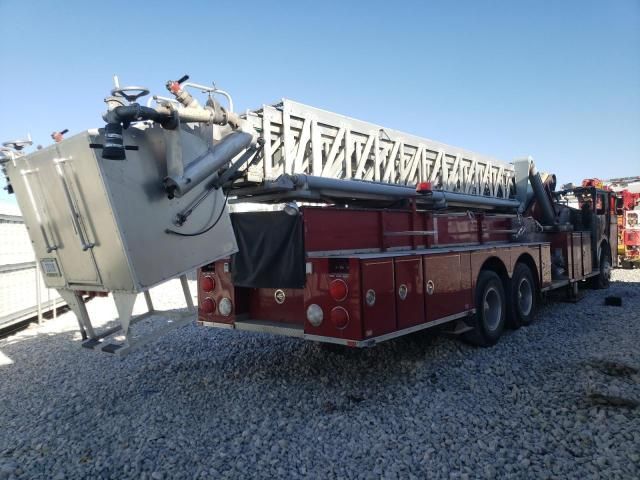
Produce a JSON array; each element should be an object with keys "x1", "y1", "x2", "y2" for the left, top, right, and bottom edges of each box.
[{"x1": 5, "y1": 125, "x2": 237, "y2": 353}]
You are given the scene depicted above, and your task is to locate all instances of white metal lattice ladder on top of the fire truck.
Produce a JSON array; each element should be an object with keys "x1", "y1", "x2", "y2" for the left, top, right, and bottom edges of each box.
[{"x1": 249, "y1": 100, "x2": 515, "y2": 198}]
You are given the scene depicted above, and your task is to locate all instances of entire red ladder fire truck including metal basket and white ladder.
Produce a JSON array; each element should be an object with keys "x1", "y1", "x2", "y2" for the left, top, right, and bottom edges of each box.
[{"x1": 0, "y1": 75, "x2": 617, "y2": 355}]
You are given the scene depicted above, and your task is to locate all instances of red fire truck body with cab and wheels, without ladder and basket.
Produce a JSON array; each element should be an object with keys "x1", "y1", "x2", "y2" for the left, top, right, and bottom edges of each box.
[{"x1": 198, "y1": 160, "x2": 616, "y2": 347}]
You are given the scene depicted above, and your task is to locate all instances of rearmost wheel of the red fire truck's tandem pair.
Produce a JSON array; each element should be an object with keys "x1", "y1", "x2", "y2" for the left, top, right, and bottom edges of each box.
[{"x1": 463, "y1": 270, "x2": 506, "y2": 347}]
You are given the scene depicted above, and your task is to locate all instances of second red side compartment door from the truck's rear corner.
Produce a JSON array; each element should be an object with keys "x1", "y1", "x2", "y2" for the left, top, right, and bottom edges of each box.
[{"x1": 395, "y1": 257, "x2": 425, "y2": 329}]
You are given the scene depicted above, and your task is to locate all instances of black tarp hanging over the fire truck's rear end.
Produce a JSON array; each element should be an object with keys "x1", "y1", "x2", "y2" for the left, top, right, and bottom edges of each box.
[{"x1": 231, "y1": 212, "x2": 305, "y2": 288}]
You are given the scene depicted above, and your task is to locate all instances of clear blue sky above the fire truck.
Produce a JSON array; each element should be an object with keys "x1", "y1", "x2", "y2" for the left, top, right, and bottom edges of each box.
[{"x1": 0, "y1": 0, "x2": 640, "y2": 200}]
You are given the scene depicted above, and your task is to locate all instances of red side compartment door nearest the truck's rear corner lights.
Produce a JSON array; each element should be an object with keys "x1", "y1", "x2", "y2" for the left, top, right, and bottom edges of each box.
[{"x1": 361, "y1": 258, "x2": 397, "y2": 338}]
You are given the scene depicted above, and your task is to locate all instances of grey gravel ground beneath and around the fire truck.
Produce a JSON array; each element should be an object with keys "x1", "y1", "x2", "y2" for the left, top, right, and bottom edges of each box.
[{"x1": 0, "y1": 270, "x2": 640, "y2": 479}]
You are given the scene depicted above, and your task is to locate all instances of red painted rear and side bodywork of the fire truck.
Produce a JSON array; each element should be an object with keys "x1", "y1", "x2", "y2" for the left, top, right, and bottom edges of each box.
[{"x1": 198, "y1": 207, "x2": 560, "y2": 342}]
